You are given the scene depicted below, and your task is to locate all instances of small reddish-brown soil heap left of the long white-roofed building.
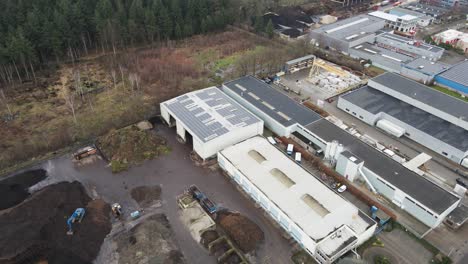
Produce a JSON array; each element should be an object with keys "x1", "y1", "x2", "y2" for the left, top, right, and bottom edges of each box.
[{"x1": 218, "y1": 212, "x2": 264, "y2": 253}]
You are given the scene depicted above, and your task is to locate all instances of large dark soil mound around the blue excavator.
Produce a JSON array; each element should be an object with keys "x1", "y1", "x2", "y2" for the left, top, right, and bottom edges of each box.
[{"x1": 0, "y1": 182, "x2": 111, "y2": 264}]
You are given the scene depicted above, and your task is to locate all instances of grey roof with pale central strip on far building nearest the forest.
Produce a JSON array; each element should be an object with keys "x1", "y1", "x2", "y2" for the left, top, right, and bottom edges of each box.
[{"x1": 313, "y1": 15, "x2": 383, "y2": 39}]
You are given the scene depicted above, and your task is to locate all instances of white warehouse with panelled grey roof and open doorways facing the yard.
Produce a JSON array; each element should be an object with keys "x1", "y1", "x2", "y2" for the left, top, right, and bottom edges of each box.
[{"x1": 160, "y1": 87, "x2": 263, "y2": 159}]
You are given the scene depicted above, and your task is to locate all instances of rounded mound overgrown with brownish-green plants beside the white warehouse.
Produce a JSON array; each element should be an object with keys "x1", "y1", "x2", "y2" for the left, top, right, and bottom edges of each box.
[{"x1": 96, "y1": 125, "x2": 170, "y2": 173}]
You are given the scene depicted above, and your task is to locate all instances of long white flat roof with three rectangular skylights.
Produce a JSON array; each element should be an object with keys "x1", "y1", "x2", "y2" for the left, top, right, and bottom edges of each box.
[{"x1": 220, "y1": 136, "x2": 373, "y2": 242}]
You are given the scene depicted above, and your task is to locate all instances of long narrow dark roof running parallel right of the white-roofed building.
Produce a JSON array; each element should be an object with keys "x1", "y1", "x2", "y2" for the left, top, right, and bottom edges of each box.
[{"x1": 307, "y1": 119, "x2": 459, "y2": 214}]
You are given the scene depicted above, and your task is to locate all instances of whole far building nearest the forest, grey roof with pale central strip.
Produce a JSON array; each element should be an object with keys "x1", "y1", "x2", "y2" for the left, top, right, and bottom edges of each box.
[{"x1": 310, "y1": 15, "x2": 385, "y2": 53}]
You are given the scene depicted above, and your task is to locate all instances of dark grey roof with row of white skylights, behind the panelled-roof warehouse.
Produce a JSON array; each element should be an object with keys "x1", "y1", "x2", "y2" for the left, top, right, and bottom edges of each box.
[{"x1": 223, "y1": 76, "x2": 322, "y2": 127}]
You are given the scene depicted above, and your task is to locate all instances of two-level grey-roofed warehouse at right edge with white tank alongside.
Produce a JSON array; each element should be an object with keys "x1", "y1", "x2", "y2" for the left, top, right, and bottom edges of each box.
[{"x1": 338, "y1": 73, "x2": 468, "y2": 166}]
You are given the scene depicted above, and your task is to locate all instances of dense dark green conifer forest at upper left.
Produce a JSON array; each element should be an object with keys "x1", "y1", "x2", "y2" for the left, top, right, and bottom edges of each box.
[{"x1": 0, "y1": 0, "x2": 239, "y2": 83}]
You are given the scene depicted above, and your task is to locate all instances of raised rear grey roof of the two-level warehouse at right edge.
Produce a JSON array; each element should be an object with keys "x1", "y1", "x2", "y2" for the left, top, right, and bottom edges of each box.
[{"x1": 369, "y1": 73, "x2": 468, "y2": 118}]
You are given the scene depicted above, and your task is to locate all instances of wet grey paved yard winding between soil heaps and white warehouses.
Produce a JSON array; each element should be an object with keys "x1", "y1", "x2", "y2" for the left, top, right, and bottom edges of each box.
[{"x1": 23, "y1": 126, "x2": 292, "y2": 264}]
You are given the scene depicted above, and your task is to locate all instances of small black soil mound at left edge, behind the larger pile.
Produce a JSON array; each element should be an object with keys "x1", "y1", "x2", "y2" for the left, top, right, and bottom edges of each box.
[{"x1": 0, "y1": 169, "x2": 47, "y2": 210}]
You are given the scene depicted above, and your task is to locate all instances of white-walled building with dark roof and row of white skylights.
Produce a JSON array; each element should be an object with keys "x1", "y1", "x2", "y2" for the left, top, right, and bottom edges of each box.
[{"x1": 223, "y1": 76, "x2": 321, "y2": 136}]
